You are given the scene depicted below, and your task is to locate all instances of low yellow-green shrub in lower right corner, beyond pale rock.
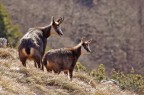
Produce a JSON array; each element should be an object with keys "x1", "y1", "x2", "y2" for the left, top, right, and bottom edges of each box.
[{"x1": 112, "y1": 70, "x2": 144, "y2": 95}]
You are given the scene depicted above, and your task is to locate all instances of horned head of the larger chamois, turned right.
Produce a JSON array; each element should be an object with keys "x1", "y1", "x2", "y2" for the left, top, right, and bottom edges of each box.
[{"x1": 51, "y1": 16, "x2": 64, "y2": 36}]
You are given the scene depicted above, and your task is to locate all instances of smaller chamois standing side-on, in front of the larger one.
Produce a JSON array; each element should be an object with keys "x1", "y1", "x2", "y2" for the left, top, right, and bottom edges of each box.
[{"x1": 43, "y1": 38, "x2": 91, "y2": 80}]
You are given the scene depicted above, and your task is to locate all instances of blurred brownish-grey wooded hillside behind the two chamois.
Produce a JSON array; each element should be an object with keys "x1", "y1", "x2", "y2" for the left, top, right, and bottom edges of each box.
[{"x1": 1, "y1": 0, "x2": 144, "y2": 75}]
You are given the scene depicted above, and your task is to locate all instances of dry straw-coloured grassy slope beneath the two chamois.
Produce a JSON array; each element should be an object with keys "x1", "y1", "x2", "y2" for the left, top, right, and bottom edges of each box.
[{"x1": 0, "y1": 48, "x2": 136, "y2": 95}]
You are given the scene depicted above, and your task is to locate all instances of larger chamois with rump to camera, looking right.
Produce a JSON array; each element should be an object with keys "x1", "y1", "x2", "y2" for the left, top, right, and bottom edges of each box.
[{"x1": 18, "y1": 17, "x2": 64, "y2": 70}]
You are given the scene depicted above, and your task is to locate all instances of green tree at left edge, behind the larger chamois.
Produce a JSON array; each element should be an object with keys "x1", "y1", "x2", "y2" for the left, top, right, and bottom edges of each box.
[{"x1": 0, "y1": 3, "x2": 22, "y2": 46}]
